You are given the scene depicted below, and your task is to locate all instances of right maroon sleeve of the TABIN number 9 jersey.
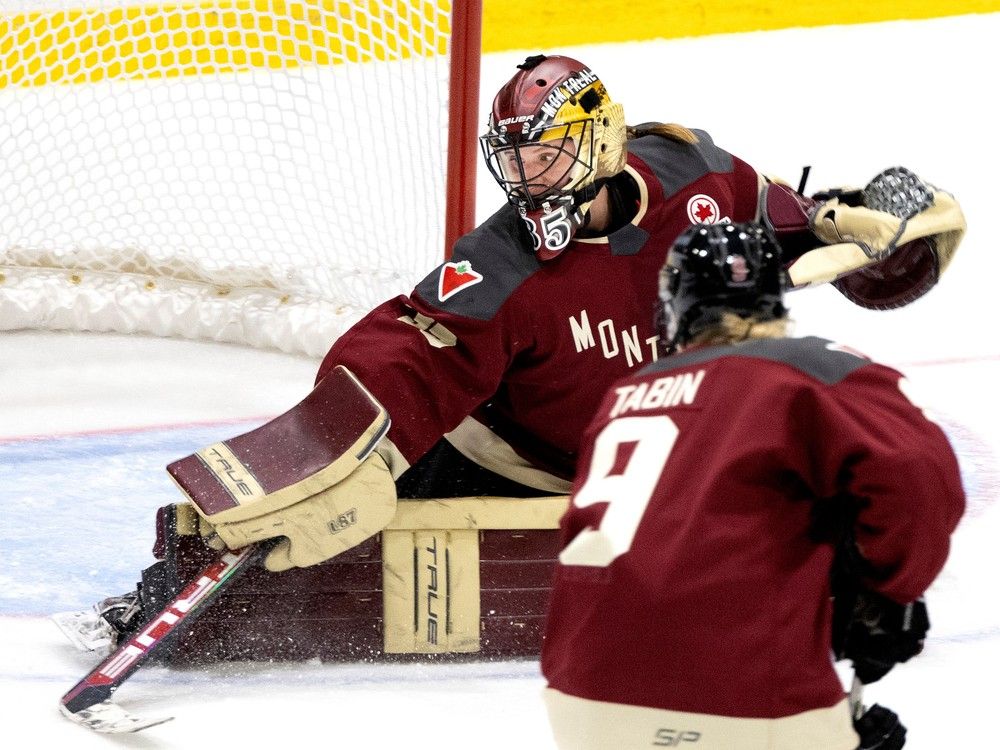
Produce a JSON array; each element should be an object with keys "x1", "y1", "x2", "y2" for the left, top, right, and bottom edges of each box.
[{"x1": 814, "y1": 364, "x2": 964, "y2": 603}]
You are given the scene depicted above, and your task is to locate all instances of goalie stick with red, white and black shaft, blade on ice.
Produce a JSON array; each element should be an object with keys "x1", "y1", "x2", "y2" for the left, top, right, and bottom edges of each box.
[{"x1": 59, "y1": 539, "x2": 280, "y2": 734}]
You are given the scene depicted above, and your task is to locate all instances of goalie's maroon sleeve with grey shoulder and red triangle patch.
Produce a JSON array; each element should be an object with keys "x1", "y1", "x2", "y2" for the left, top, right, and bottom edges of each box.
[{"x1": 317, "y1": 206, "x2": 540, "y2": 463}]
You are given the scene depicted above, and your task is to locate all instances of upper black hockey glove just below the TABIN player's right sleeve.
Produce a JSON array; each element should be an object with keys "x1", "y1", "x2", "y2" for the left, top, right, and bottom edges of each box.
[{"x1": 834, "y1": 591, "x2": 930, "y2": 685}]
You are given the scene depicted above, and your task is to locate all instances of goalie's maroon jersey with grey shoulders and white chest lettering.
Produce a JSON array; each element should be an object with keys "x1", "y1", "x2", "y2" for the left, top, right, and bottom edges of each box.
[{"x1": 319, "y1": 131, "x2": 758, "y2": 490}]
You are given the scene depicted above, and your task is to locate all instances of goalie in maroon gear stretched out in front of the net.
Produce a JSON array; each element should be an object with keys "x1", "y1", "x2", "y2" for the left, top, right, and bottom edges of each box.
[{"x1": 50, "y1": 55, "x2": 965, "y2": 661}]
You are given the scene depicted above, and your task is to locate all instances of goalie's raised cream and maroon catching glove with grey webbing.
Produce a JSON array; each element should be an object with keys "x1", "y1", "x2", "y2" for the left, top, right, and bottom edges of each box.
[{"x1": 788, "y1": 167, "x2": 966, "y2": 309}]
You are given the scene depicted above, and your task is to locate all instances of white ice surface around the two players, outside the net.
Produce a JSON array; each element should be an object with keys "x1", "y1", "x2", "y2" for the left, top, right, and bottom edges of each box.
[{"x1": 0, "y1": 14, "x2": 1000, "y2": 750}]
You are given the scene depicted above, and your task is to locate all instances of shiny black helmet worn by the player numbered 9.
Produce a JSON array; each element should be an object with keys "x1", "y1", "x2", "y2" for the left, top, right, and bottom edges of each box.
[{"x1": 657, "y1": 223, "x2": 785, "y2": 352}]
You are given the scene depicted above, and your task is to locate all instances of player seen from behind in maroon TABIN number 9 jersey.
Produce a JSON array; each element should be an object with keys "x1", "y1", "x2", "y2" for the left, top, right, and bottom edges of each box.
[{"x1": 542, "y1": 224, "x2": 964, "y2": 750}]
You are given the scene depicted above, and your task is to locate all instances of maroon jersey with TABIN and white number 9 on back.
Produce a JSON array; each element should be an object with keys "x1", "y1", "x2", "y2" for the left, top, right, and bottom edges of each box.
[{"x1": 542, "y1": 338, "x2": 964, "y2": 719}]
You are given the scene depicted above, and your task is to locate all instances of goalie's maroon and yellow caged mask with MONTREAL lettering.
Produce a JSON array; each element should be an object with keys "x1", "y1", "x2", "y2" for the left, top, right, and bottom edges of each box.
[{"x1": 480, "y1": 55, "x2": 626, "y2": 260}]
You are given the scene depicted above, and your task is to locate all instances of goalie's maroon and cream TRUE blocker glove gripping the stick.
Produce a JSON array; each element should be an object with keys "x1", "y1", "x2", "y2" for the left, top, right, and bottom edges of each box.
[{"x1": 167, "y1": 367, "x2": 396, "y2": 572}]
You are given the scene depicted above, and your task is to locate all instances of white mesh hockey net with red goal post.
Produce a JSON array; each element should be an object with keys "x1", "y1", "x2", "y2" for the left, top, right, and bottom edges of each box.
[{"x1": 0, "y1": 0, "x2": 479, "y2": 356}]
